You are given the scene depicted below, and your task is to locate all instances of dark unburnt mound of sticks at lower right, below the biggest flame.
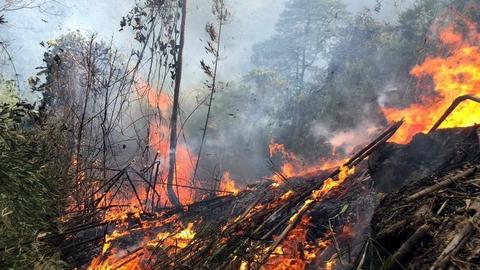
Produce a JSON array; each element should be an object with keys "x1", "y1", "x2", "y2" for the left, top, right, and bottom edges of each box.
[{"x1": 365, "y1": 126, "x2": 480, "y2": 269}]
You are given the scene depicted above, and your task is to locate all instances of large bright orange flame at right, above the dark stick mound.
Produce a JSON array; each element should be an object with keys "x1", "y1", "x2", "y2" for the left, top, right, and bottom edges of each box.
[{"x1": 383, "y1": 15, "x2": 480, "y2": 144}]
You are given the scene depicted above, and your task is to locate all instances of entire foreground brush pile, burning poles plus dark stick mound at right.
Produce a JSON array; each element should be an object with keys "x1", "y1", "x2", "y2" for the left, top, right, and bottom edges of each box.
[{"x1": 47, "y1": 122, "x2": 480, "y2": 269}]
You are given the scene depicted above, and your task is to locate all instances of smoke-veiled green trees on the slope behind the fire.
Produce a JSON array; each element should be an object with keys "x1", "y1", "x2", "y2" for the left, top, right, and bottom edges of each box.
[{"x1": 230, "y1": 0, "x2": 480, "y2": 160}]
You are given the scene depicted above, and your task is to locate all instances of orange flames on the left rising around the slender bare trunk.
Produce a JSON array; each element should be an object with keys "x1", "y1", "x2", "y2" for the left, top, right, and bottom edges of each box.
[{"x1": 88, "y1": 84, "x2": 246, "y2": 270}]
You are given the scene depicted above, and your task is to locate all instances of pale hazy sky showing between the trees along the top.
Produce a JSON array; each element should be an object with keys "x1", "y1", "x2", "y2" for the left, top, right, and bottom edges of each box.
[{"x1": 0, "y1": 0, "x2": 413, "y2": 96}]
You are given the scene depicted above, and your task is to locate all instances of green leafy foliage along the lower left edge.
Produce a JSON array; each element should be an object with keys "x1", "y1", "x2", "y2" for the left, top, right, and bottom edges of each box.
[{"x1": 0, "y1": 99, "x2": 68, "y2": 269}]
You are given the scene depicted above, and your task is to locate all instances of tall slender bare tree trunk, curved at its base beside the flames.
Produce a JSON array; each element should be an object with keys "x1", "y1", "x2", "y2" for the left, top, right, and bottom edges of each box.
[{"x1": 167, "y1": 0, "x2": 187, "y2": 207}]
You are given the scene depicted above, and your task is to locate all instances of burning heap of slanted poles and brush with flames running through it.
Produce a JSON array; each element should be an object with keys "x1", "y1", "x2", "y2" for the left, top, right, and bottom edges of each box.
[{"x1": 45, "y1": 122, "x2": 402, "y2": 269}]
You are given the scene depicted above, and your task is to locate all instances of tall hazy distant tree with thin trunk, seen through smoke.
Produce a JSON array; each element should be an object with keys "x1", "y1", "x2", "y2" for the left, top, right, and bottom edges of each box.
[{"x1": 252, "y1": 0, "x2": 349, "y2": 152}]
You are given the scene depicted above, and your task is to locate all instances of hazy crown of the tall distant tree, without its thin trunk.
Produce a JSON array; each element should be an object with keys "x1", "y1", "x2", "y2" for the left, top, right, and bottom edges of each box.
[{"x1": 252, "y1": 0, "x2": 347, "y2": 89}]
